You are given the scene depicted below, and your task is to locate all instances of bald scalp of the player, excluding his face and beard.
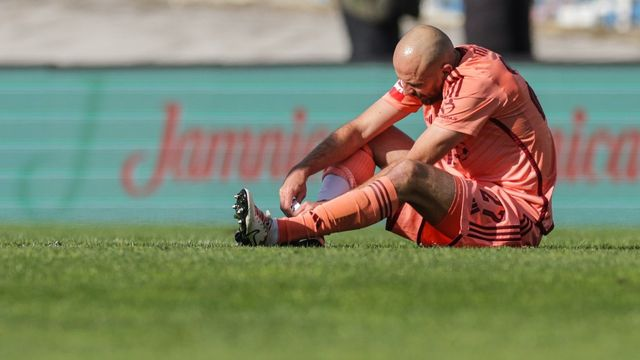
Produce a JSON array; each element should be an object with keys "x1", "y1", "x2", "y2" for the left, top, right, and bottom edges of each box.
[{"x1": 393, "y1": 25, "x2": 456, "y2": 72}]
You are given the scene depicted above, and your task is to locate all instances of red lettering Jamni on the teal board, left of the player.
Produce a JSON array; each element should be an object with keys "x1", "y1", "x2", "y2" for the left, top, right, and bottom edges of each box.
[{"x1": 121, "y1": 103, "x2": 328, "y2": 197}]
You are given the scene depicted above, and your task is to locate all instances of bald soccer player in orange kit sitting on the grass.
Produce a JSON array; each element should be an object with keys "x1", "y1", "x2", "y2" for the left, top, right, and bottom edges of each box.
[{"x1": 234, "y1": 25, "x2": 556, "y2": 246}]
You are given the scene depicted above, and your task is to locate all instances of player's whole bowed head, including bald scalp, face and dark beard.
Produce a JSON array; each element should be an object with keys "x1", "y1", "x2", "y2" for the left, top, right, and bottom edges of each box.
[{"x1": 393, "y1": 25, "x2": 460, "y2": 104}]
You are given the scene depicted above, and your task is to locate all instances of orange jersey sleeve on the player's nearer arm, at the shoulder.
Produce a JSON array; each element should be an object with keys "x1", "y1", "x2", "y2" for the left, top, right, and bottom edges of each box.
[{"x1": 433, "y1": 79, "x2": 500, "y2": 136}]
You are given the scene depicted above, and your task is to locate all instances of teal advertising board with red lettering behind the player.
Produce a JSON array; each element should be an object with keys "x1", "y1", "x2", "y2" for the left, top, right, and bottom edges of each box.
[{"x1": 0, "y1": 64, "x2": 640, "y2": 226}]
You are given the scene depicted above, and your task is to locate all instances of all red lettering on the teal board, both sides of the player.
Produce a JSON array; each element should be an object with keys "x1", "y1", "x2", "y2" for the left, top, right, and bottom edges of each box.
[{"x1": 121, "y1": 103, "x2": 640, "y2": 197}]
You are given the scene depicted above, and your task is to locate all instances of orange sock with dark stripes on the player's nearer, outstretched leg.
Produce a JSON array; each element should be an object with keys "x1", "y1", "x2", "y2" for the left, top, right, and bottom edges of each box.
[{"x1": 277, "y1": 176, "x2": 399, "y2": 244}]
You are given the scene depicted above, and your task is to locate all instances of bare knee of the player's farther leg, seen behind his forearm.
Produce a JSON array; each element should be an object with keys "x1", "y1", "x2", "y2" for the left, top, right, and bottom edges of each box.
[{"x1": 369, "y1": 126, "x2": 414, "y2": 168}]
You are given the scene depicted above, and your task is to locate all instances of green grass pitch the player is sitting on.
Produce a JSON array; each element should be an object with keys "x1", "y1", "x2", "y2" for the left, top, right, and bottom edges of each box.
[{"x1": 0, "y1": 226, "x2": 640, "y2": 359}]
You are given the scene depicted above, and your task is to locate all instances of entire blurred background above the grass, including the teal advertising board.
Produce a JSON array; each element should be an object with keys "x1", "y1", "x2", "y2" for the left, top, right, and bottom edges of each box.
[{"x1": 0, "y1": 0, "x2": 640, "y2": 225}]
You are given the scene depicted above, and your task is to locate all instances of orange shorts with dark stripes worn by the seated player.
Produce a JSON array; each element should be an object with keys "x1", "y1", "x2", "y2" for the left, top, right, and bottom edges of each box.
[{"x1": 387, "y1": 177, "x2": 542, "y2": 246}]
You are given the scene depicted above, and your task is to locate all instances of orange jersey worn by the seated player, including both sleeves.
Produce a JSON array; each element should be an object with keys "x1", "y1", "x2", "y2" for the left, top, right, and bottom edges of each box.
[{"x1": 383, "y1": 45, "x2": 556, "y2": 233}]
